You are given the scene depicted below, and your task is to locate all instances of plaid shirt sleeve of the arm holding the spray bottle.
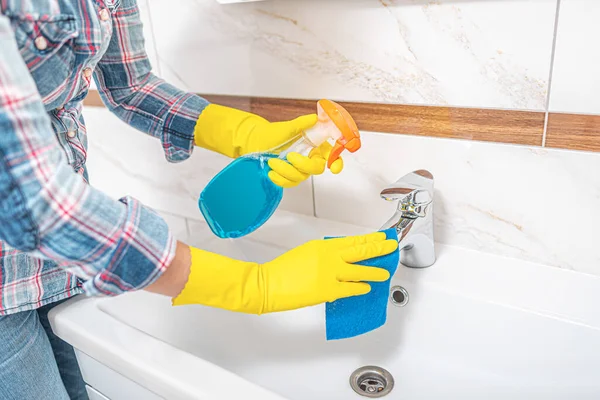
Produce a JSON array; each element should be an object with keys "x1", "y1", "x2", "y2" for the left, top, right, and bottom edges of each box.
[{"x1": 94, "y1": 0, "x2": 208, "y2": 162}]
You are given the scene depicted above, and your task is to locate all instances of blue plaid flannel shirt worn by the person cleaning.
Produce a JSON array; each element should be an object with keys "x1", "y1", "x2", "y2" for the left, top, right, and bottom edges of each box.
[{"x1": 0, "y1": 0, "x2": 207, "y2": 315}]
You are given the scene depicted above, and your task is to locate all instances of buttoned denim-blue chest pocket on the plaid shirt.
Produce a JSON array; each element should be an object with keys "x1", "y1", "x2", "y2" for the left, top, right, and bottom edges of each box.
[{"x1": 6, "y1": 13, "x2": 78, "y2": 103}]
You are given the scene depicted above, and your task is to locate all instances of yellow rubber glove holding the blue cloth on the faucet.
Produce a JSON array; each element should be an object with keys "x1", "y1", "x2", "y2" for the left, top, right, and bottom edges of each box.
[{"x1": 173, "y1": 232, "x2": 398, "y2": 314}]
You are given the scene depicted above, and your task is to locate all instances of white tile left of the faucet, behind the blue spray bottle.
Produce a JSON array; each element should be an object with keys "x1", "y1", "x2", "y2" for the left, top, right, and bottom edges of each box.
[{"x1": 84, "y1": 107, "x2": 313, "y2": 220}]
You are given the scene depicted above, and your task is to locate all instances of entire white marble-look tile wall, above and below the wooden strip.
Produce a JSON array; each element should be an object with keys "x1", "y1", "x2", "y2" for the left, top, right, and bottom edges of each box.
[{"x1": 85, "y1": 0, "x2": 600, "y2": 275}]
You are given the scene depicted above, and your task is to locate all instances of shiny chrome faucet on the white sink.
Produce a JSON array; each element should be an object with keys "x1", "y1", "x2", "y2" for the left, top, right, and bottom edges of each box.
[{"x1": 381, "y1": 170, "x2": 435, "y2": 268}]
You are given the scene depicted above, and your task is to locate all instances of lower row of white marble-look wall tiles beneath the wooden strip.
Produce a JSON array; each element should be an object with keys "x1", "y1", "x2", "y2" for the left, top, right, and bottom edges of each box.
[{"x1": 85, "y1": 108, "x2": 600, "y2": 275}]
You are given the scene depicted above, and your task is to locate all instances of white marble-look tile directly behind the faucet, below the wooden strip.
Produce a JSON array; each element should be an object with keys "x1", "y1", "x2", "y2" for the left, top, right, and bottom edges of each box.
[{"x1": 315, "y1": 133, "x2": 600, "y2": 275}]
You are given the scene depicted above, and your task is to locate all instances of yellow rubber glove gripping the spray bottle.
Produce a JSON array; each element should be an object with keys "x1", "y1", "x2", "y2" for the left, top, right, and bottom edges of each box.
[{"x1": 194, "y1": 104, "x2": 344, "y2": 188}]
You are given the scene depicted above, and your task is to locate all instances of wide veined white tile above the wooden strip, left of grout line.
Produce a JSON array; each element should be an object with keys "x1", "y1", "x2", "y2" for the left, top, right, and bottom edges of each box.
[{"x1": 150, "y1": 0, "x2": 556, "y2": 110}]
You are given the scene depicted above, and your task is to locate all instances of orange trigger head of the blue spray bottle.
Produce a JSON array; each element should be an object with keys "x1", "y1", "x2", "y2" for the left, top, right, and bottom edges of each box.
[{"x1": 319, "y1": 100, "x2": 361, "y2": 168}]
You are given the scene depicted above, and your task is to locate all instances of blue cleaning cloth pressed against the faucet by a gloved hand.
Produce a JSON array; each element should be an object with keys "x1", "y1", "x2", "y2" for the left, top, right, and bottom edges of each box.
[{"x1": 325, "y1": 229, "x2": 400, "y2": 340}]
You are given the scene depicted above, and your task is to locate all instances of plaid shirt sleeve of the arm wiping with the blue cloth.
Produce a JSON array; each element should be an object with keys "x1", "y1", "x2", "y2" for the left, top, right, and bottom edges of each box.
[{"x1": 0, "y1": 15, "x2": 175, "y2": 295}]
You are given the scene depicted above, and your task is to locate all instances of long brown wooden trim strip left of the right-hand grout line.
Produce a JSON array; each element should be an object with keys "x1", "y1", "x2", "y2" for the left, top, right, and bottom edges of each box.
[{"x1": 84, "y1": 91, "x2": 545, "y2": 146}]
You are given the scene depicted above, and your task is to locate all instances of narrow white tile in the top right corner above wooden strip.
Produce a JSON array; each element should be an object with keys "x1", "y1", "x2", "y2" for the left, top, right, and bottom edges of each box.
[{"x1": 550, "y1": 0, "x2": 600, "y2": 114}]
